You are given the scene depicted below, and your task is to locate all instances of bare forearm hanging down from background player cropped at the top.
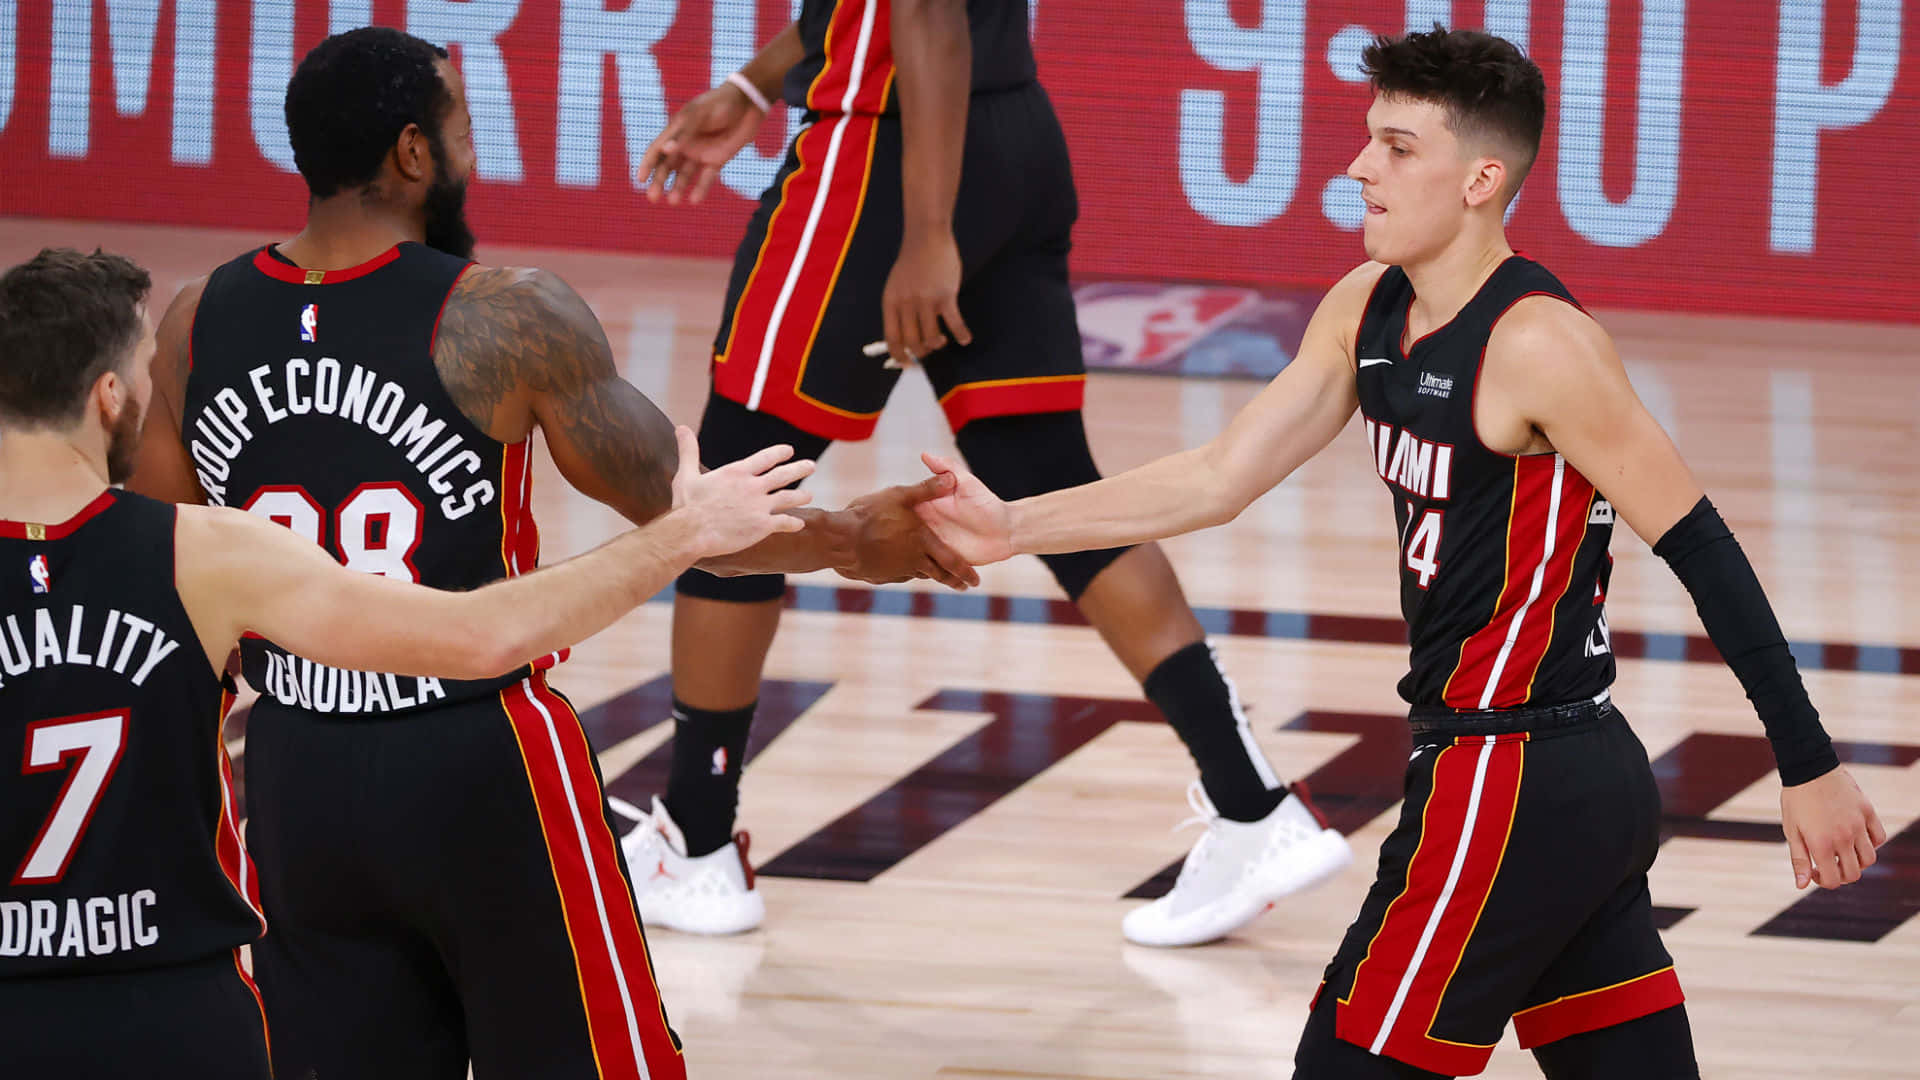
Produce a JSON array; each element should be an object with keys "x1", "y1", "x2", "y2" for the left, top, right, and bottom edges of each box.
[{"x1": 891, "y1": 0, "x2": 973, "y2": 240}]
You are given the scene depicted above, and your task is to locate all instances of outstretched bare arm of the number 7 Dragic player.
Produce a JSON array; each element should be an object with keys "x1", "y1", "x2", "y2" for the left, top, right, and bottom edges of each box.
[{"x1": 175, "y1": 429, "x2": 812, "y2": 678}]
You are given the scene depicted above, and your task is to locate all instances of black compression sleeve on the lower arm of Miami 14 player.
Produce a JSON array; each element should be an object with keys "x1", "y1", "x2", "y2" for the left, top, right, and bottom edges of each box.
[{"x1": 1653, "y1": 496, "x2": 1839, "y2": 788}]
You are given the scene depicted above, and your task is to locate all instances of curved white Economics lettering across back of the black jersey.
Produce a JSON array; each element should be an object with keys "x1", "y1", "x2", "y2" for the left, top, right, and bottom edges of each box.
[{"x1": 186, "y1": 356, "x2": 499, "y2": 521}]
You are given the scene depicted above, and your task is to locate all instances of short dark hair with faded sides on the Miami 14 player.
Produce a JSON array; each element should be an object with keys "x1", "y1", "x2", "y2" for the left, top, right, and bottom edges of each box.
[{"x1": 1359, "y1": 23, "x2": 1548, "y2": 198}]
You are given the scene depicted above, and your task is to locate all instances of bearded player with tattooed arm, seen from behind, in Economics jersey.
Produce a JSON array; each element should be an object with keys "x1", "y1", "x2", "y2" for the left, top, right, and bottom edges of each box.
[{"x1": 121, "y1": 29, "x2": 972, "y2": 1080}]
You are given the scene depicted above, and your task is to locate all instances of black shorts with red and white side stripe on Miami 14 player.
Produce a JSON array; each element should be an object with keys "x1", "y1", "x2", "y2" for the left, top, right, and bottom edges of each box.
[{"x1": 1296, "y1": 700, "x2": 1682, "y2": 1080}]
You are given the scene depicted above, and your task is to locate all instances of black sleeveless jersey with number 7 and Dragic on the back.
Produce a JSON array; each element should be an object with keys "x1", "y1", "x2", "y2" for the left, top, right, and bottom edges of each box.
[{"x1": 0, "y1": 490, "x2": 265, "y2": 976}]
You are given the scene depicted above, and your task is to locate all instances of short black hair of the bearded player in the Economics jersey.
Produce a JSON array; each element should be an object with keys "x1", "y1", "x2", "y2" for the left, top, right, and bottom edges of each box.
[{"x1": 286, "y1": 27, "x2": 453, "y2": 198}]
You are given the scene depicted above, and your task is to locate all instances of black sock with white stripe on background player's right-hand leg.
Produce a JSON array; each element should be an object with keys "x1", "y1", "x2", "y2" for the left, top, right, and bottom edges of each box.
[{"x1": 1142, "y1": 642, "x2": 1286, "y2": 821}]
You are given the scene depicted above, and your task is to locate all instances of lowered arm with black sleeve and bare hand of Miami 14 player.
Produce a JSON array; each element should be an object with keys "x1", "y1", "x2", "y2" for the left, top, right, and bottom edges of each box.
[{"x1": 1478, "y1": 298, "x2": 1885, "y2": 888}]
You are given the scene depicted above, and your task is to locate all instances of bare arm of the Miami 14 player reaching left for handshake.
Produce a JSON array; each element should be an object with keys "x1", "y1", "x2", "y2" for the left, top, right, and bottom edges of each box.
[{"x1": 920, "y1": 263, "x2": 1384, "y2": 565}]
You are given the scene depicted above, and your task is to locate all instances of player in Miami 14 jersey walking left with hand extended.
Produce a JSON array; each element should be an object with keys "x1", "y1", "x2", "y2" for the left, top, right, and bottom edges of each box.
[{"x1": 922, "y1": 27, "x2": 1885, "y2": 1080}]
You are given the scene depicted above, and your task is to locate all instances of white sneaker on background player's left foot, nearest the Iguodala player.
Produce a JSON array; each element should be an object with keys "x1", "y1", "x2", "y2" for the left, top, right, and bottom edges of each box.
[{"x1": 607, "y1": 796, "x2": 766, "y2": 934}]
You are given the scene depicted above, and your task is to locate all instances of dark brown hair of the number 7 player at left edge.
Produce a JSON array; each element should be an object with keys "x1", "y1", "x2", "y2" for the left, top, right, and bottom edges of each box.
[{"x1": 0, "y1": 248, "x2": 154, "y2": 425}]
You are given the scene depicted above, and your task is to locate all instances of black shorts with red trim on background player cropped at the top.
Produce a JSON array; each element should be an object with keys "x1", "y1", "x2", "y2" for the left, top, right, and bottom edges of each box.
[{"x1": 712, "y1": 83, "x2": 1087, "y2": 440}]
